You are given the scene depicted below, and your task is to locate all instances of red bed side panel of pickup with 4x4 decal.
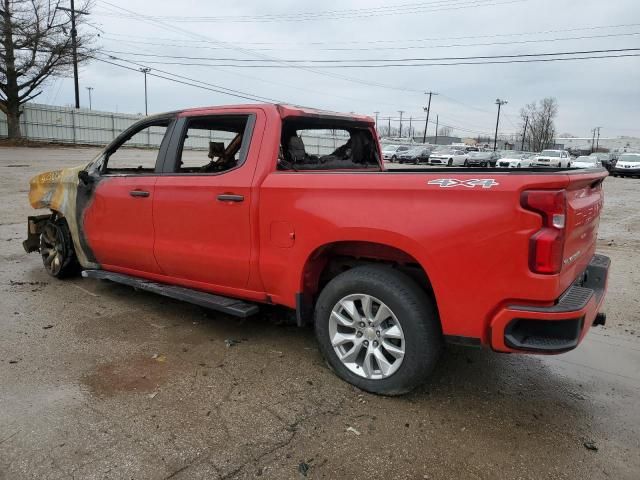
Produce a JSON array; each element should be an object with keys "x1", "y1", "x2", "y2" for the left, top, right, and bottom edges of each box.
[{"x1": 259, "y1": 172, "x2": 592, "y2": 337}]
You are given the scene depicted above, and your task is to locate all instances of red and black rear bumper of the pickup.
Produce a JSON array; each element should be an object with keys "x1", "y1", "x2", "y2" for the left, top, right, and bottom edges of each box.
[{"x1": 490, "y1": 255, "x2": 611, "y2": 354}]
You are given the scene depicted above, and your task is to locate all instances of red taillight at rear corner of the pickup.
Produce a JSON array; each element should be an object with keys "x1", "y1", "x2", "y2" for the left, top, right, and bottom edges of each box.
[{"x1": 521, "y1": 190, "x2": 567, "y2": 275}]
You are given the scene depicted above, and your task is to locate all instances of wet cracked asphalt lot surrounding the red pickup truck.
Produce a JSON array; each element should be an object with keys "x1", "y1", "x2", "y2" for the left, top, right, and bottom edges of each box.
[{"x1": 0, "y1": 147, "x2": 640, "y2": 480}]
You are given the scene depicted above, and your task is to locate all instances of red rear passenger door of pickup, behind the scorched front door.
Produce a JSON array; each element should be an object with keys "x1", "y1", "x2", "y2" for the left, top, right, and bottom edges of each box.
[{"x1": 153, "y1": 112, "x2": 262, "y2": 289}]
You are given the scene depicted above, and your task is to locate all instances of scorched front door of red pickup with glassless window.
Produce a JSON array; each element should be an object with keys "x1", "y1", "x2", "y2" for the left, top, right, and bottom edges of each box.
[{"x1": 82, "y1": 118, "x2": 172, "y2": 275}]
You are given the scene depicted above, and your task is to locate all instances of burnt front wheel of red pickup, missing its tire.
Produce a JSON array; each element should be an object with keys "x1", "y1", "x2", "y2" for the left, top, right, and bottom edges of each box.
[{"x1": 40, "y1": 218, "x2": 80, "y2": 278}]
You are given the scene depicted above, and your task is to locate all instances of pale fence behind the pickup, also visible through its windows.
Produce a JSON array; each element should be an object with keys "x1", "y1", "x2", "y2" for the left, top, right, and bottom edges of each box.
[{"x1": 0, "y1": 103, "x2": 348, "y2": 155}]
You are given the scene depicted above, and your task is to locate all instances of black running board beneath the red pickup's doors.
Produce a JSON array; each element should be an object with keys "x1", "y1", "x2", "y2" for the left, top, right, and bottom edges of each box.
[{"x1": 82, "y1": 270, "x2": 259, "y2": 318}]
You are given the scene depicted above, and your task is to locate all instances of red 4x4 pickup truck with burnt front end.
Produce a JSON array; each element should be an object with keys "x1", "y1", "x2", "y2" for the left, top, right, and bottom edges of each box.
[{"x1": 24, "y1": 105, "x2": 610, "y2": 394}]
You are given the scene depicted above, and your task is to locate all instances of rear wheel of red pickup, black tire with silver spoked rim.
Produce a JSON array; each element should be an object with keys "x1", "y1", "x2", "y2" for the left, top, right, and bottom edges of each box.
[{"x1": 315, "y1": 265, "x2": 443, "y2": 395}]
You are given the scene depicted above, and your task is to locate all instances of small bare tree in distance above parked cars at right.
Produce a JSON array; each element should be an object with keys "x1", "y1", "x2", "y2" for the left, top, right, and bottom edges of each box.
[{"x1": 520, "y1": 97, "x2": 558, "y2": 152}]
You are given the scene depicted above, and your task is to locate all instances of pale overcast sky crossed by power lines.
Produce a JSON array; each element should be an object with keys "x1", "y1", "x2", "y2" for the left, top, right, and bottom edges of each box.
[{"x1": 38, "y1": 0, "x2": 640, "y2": 137}]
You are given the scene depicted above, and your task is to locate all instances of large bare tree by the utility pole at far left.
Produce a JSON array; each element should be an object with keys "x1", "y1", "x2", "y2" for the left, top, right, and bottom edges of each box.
[{"x1": 0, "y1": 0, "x2": 94, "y2": 139}]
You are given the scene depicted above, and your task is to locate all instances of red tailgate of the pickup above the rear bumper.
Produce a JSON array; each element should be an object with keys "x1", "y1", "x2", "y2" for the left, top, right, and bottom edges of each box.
[{"x1": 561, "y1": 170, "x2": 607, "y2": 289}]
